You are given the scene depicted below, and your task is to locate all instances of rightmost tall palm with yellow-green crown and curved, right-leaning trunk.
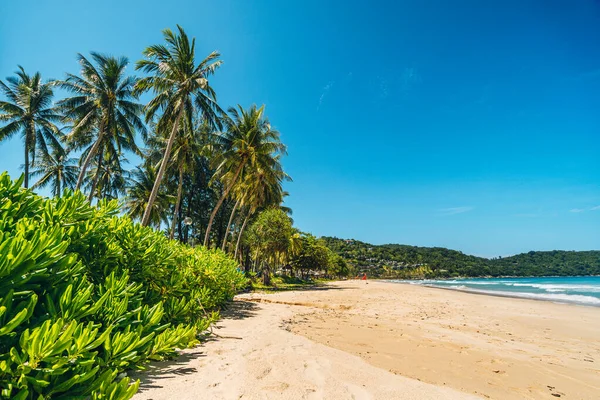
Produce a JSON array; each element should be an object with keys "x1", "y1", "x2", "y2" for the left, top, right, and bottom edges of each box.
[{"x1": 204, "y1": 105, "x2": 286, "y2": 246}]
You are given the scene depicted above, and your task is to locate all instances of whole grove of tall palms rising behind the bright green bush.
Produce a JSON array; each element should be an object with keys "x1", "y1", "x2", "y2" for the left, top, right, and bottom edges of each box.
[{"x1": 0, "y1": 26, "x2": 289, "y2": 260}]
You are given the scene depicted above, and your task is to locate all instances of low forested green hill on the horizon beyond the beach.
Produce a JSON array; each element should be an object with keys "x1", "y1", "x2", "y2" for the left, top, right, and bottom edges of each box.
[{"x1": 322, "y1": 237, "x2": 600, "y2": 278}]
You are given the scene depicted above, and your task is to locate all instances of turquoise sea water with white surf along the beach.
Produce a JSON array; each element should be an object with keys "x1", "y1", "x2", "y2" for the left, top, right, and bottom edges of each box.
[{"x1": 402, "y1": 276, "x2": 600, "y2": 306}]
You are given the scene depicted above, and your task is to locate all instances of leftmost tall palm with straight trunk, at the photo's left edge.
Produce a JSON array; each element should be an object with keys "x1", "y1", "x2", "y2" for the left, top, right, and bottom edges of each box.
[{"x1": 0, "y1": 65, "x2": 60, "y2": 188}]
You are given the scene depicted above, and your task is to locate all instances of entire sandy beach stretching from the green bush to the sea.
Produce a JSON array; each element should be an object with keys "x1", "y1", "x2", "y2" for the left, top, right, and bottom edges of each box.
[{"x1": 133, "y1": 281, "x2": 600, "y2": 400}]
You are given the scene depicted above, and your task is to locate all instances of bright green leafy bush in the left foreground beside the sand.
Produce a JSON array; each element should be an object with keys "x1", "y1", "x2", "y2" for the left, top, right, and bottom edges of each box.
[{"x1": 0, "y1": 173, "x2": 245, "y2": 399}]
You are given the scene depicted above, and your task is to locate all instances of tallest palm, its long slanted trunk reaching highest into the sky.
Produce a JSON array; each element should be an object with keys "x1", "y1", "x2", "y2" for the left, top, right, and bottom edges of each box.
[{"x1": 136, "y1": 25, "x2": 223, "y2": 225}]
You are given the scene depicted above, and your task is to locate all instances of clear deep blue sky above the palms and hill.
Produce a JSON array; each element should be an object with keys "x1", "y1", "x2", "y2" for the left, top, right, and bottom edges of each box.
[{"x1": 0, "y1": 0, "x2": 600, "y2": 256}]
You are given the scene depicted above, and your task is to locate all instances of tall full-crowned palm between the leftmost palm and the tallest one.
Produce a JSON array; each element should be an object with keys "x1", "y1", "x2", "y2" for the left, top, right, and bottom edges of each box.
[{"x1": 58, "y1": 52, "x2": 146, "y2": 194}]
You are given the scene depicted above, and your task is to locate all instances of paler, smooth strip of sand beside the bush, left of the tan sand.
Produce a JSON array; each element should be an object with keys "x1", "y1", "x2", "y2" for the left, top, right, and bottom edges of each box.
[{"x1": 132, "y1": 293, "x2": 476, "y2": 400}]
